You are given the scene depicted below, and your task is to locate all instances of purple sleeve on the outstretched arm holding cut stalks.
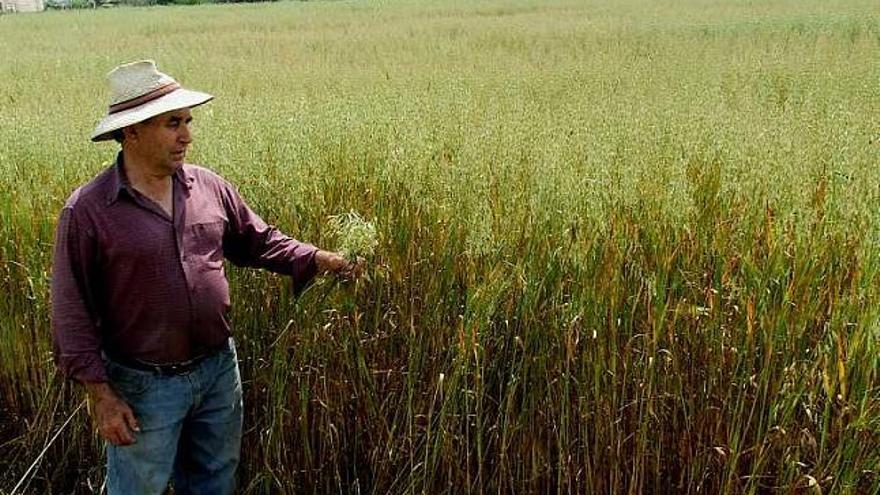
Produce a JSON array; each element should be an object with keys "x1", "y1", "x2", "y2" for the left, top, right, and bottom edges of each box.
[{"x1": 223, "y1": 183, "x2": 318, "y2": 292}]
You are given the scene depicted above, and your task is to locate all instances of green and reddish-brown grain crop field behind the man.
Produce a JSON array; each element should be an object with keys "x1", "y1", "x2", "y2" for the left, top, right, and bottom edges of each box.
[{"x1": 0, "y1": 0, "x2": 880, "y2": 494}]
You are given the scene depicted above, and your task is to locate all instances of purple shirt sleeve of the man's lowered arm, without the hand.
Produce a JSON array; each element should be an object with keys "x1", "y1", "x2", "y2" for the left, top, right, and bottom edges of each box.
[{"x1": 52, "y1": 206, "x2": 107, "y2": 382}]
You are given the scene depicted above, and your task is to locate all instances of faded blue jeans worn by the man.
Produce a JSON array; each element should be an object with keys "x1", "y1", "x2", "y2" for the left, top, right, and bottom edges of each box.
[{"x1": 107, "y1": 338, "x2": 242, "y2": 495}]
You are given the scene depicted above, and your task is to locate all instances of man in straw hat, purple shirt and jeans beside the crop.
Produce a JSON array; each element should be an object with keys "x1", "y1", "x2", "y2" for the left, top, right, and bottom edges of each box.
[{"x1": 52, "y1": 61, "x2": 363, "y2": 495}]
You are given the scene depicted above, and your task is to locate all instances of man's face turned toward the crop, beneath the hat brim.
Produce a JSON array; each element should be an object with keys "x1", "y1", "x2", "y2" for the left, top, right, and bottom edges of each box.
[{"x1": 126, "y1": 108, "x2": 192, "y2": 175}]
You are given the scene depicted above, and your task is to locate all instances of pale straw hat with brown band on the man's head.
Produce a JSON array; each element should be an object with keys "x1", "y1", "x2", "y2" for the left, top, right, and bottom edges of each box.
[{"x1": 92, "y1": 60, "x2": 214, "y2": 141}]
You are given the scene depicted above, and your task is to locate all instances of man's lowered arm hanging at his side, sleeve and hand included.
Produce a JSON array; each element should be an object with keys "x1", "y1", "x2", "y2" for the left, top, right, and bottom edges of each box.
[{"x1": 52, "y1": 207, "x2": 139, "y2": 445}]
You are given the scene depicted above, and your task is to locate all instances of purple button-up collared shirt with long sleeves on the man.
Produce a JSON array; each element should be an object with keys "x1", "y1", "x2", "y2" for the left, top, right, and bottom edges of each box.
[{"x1": 52, "y1": 153, "x2": 317, "y2": 382}]
